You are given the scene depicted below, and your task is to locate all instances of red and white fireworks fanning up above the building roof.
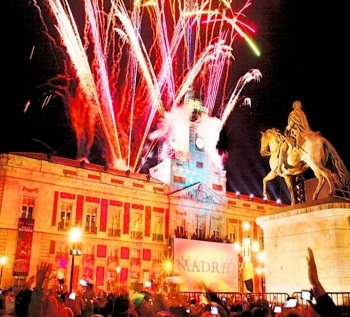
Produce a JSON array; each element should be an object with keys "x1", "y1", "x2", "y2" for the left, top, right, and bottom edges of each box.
[{"x1": 39, "y1": 0, "x2": 255, "y2": 171}]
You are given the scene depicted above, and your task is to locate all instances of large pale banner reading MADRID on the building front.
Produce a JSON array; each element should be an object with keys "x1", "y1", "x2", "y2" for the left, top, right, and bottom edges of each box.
[{"x1": 174, "y1": 238, "x2": 239, "y2": 292}]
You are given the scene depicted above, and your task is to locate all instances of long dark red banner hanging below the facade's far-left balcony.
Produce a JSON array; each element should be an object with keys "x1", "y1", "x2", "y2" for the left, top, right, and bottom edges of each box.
[{"x1": 12, "y1": 218, "x2": 34, "y2": 276}]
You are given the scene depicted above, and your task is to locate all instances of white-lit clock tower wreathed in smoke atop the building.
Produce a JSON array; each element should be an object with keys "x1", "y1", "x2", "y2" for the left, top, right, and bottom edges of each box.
[{"x1": 150, "y1": 91, "x2": 226, "y2": 197}]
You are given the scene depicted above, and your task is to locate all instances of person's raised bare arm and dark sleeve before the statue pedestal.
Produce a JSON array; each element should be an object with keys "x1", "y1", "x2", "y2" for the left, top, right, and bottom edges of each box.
[{"x1": 306, "y1": 248, "x2": 348, "y2": 317}]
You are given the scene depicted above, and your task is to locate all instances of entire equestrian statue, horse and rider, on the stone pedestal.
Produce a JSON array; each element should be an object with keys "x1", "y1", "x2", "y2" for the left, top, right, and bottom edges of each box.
[{"x1": 260, "y1": 101, "x2": 350, "y2": 205}]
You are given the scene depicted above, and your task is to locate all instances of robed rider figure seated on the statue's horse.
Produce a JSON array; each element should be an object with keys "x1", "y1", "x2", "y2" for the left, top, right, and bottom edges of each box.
[{"x1": 276, "y1": 100, "x2": 311, "y2": 174}]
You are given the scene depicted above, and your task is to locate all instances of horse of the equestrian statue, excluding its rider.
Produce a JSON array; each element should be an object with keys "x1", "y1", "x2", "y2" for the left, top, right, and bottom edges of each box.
[{"x1": 260, "y1": 128, "x2": 350, "y2": 205}]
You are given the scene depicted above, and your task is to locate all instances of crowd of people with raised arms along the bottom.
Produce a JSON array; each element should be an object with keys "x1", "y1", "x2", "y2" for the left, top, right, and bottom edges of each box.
[{"x1": 0, "y1": 248, "x2": 350, "y2": 317}]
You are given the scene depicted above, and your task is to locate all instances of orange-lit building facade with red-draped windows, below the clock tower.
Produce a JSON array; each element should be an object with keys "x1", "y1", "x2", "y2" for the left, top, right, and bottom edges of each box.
[{"x1": 0, "y1": 148, "x2": 276, "y2": 290}]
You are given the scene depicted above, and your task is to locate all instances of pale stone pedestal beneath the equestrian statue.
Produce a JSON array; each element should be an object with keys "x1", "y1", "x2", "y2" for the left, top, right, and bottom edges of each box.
[{"x1": 257, "y1": 197, "x2": 350, "y2": 295}]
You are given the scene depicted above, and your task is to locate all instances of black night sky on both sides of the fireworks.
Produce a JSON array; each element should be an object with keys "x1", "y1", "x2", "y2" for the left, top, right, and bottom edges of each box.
[{"x1": 0, "y1": 0, "x2": 350, "y2": 203}]
